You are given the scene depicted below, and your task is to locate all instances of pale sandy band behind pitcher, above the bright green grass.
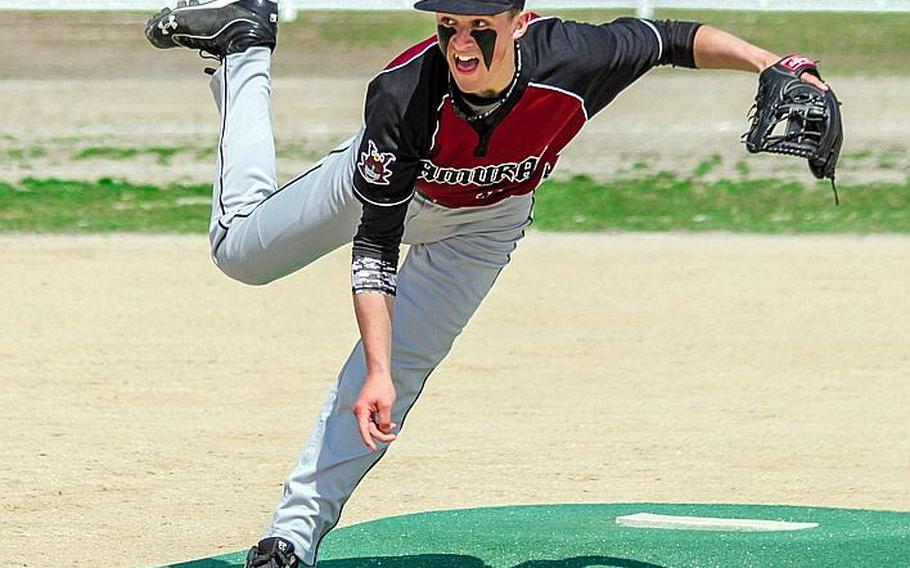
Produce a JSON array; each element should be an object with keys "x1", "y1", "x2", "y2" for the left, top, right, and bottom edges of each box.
[{"x1": 0, "y1": 73, "x2": 910, "y2": 184}]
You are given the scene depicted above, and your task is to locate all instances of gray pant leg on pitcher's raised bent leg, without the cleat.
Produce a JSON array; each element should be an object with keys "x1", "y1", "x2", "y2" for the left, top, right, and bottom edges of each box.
[{"x1": 209, "y1": 47, "x2": 361, "y2": 284}]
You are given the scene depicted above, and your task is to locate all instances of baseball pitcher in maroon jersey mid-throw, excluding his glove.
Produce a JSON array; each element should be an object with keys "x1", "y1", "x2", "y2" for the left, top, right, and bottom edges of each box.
[{"x1": 146, "y1": 0, "x2": 823, "y2": 568}]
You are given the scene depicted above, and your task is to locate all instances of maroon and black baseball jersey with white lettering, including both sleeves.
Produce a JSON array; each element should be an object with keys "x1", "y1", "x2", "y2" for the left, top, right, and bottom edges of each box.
[{"x1": 354, "y1": 17, "x2": 698, "y2": 293}]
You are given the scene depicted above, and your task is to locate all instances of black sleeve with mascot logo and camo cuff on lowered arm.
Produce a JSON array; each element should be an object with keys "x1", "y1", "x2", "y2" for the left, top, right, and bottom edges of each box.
[{"x1": 351, "y1": 65, "x2": 434, "y2": 295}]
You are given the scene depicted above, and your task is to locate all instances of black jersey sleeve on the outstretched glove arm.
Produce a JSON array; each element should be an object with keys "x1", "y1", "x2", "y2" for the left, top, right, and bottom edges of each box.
[{"x1": 548, "y1": 18, "x2": 701, "y2": 117}]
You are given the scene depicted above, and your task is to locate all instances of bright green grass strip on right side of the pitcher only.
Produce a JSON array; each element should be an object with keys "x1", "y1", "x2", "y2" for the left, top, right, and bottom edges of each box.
[{"x1": 534, "y1": 173, "x2": 910, "y2": 234}]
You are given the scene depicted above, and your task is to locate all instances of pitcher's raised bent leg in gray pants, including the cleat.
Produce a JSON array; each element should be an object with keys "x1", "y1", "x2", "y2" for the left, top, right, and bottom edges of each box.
[{"x1": 146, "y1": 0, "x2": 361, "y2": 284}]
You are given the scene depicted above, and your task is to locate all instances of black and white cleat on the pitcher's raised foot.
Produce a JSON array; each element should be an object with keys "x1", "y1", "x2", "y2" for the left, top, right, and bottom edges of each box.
[{"x1": 145, "y1": 0, "x2": 278, "y2": 58}]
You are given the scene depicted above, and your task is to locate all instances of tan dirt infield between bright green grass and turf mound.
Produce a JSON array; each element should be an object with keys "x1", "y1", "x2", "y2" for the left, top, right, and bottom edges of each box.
[{"x1": 0, "y1": 234, "x2": 910, "y2": 568}]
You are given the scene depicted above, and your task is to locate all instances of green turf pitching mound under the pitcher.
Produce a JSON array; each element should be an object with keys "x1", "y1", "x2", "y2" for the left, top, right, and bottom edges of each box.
[{"x1": 164, "y1": 503, "x2": 910, "y2": 568}]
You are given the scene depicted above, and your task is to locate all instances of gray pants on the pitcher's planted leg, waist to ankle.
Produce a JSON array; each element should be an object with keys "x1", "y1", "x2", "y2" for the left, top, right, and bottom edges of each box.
[{"x1": 256, "y1": 195, "x2": 531, "y2": 564}]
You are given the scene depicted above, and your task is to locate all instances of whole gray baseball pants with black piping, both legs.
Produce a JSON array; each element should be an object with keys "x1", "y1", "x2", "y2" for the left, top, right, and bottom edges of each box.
[{"x1": 210, "y1": 48, "x2": 532, "y2": 565}]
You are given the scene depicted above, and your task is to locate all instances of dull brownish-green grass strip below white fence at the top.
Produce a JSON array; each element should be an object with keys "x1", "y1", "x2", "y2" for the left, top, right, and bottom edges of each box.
[{"x1": 0, "y1": 10, "x2": 910, "y2": 79}]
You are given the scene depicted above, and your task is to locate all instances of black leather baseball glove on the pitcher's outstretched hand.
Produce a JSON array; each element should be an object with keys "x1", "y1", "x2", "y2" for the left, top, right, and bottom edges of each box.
[{"x1": 743, "y1": 55, "x2": 844, "y2": 203}]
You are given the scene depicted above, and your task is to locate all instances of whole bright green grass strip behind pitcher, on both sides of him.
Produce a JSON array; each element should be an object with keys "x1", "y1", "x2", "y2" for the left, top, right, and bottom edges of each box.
[{"x1": 0, "y1": 173, "x2": 910, "y2": 234}]
